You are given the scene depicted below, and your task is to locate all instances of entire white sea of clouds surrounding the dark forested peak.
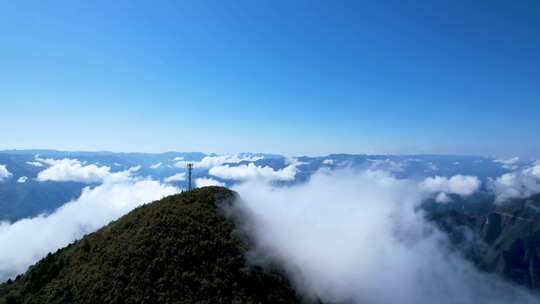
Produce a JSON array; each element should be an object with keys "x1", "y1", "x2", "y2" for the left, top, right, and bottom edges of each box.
[{"x1": 0, "y1": 155, "x2": 540, "y2": 304}]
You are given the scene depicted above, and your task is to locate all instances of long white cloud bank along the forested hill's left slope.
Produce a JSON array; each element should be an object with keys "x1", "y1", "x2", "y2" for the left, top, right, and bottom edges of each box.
[{"x1": 0, "y1": 171, "x2": 178, "y2": 281}]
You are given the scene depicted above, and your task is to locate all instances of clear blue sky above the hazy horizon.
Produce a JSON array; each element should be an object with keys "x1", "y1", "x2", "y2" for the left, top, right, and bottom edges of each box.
[{"x1": 0, "y1": 0, "x2": 540, "y2": 157}]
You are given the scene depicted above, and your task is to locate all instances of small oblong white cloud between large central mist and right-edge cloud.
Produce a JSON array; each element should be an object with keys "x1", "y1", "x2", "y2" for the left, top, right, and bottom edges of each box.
[{"x1": 420, "y1": 175, "x2": 481, "y2": 196}]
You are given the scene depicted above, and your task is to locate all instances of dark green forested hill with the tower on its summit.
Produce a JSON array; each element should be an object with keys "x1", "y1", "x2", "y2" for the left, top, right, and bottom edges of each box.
[{"x1": 0, "y1": 187, "x2": 298, "y2": 303}]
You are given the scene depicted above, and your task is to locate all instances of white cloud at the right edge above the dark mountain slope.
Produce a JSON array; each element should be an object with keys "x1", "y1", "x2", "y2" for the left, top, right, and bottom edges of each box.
[{"x1": 489, "y1": 163, "x2": 540, "y2": 203}]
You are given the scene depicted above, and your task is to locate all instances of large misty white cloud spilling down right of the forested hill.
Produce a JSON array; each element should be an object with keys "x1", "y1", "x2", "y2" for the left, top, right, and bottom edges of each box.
[{"x1": 233, "y1": 170, "x2": 537, "y2": 304}]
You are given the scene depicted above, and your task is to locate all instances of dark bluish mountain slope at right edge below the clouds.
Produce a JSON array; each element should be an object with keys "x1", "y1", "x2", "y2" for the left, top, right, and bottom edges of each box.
[{"x1": 431, "y1": 195, "x2": 540, "y2": 290}]
